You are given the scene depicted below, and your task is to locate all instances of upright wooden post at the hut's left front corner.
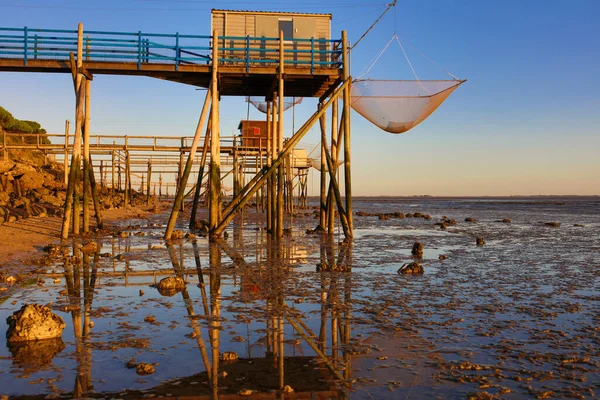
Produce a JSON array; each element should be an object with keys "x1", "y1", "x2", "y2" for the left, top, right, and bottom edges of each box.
[{"x1": 208, "y1": 29, "x2": 221, "y2": 234}]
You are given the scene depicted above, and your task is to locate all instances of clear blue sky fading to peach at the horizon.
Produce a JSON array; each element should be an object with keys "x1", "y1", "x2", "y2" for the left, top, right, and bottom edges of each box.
[{"x1": 0, "y1": 0, "x2": 600, "y2": 195}]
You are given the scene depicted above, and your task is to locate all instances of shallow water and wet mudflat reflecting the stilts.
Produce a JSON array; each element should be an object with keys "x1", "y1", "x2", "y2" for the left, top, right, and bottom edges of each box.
[{"x1": 0, "y1": 198, "x2": 600, "y2": 399}]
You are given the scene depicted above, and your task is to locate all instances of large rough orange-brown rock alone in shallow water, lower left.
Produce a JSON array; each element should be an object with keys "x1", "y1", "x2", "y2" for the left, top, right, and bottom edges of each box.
[{"x1": 6, "y1": 304, "x2": 66, "y2": 342}]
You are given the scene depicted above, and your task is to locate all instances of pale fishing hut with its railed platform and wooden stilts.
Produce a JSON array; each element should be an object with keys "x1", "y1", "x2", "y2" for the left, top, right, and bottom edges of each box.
[{"x1": 165, "y1": 10, "x2": 352, "y2": 239}]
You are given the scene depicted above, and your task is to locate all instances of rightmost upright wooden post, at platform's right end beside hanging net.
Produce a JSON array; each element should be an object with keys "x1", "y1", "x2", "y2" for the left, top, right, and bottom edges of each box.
[{"x1": 342, "y1": 31, "x2": 354, "y2": 238}]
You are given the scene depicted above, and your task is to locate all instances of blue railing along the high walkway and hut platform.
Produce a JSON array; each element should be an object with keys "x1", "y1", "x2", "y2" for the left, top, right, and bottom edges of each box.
[{"x1": 0, "y1": 27, "x2": 342, "y2": 72}]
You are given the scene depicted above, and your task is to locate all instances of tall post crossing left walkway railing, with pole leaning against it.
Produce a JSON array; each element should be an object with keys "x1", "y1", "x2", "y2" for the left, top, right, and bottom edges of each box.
[{"x1": 61, "y1": 22, "x2": 85, "y2": 239}]
